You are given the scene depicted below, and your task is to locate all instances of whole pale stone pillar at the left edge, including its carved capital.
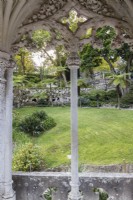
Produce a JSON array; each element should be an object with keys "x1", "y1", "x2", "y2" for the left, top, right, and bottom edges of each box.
[{"x1": 0, "y1": 52, "x2": 15, "y2": 200}]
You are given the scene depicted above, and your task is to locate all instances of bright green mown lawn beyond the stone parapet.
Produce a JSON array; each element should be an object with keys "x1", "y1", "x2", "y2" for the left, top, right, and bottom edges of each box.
[{"x1": 15, "y1": 107, "x2": 133, "y2": 167}]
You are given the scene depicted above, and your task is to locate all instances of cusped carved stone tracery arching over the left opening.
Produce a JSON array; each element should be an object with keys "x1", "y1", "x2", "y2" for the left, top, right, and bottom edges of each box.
[{"x1": 11, "y1": 19, "x2": 76, "y2": 52}]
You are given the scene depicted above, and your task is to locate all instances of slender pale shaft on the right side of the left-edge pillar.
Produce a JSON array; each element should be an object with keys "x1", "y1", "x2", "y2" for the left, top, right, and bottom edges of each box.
[{"x1": 3, "y1": 61, "x2": 15, "y2": 200}]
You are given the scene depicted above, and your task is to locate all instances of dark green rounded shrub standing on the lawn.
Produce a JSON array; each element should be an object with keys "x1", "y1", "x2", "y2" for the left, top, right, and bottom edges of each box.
[{"x1": 19, "y1": 111, "x2": 56, "y2": 136}]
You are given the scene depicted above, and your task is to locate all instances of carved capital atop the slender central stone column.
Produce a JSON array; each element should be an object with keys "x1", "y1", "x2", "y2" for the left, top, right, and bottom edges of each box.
[{"x1": 67, "y1": 52, "x2": 80, "y2": 69}]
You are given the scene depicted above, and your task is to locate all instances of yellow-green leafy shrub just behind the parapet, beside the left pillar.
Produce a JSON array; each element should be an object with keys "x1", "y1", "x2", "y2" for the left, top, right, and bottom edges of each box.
[{"x1": 13, "y1": 143, "x2": 43, "y2": 172}]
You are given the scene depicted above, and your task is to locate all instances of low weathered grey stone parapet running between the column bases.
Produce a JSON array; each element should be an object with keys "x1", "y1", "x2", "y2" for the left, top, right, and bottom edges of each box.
[{"x1": 13, "y1": 172, "x2": 133, "y2": 200}]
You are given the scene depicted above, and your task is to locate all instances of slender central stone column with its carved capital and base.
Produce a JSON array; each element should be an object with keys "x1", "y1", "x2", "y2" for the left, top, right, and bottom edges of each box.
[{"x1": 67, "y1": 52, "x2": 82, "y2": 200}]
